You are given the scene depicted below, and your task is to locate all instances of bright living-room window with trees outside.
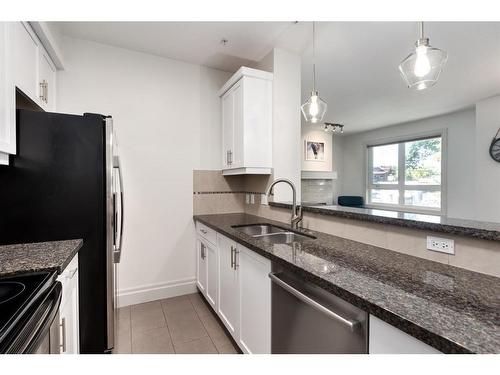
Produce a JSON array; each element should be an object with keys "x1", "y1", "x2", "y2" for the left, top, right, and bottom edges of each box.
[{"x1": 366, "y1": 135, "x2": 443, "y2": 212}]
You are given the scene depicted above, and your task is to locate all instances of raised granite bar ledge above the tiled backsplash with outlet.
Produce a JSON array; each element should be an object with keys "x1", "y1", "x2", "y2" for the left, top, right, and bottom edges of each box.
[{"x1": 269, "y1": 202, "x2": 500, "y2": 241}]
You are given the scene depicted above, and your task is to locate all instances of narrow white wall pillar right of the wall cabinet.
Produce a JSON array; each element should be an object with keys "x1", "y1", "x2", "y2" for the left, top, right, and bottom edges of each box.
[{"x1": 256, "y1": 48, "x2": 302, "y2": 202}]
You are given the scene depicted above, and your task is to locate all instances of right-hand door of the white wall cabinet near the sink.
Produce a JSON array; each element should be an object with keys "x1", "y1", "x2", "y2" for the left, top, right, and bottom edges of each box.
[{"x1": 231, "y1": 80, "x2": 245, "y2": 168}]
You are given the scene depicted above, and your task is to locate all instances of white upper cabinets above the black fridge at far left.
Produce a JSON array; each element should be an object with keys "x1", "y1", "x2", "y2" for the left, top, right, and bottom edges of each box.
[{"x1": 0, "y1": 22, "x2": 56, "y2": 164}]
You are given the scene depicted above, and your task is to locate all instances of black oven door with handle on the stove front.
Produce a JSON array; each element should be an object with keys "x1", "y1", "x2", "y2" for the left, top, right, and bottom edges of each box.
[{"x1": 5, "y1": 282, "x2": 62, "y2": 354}]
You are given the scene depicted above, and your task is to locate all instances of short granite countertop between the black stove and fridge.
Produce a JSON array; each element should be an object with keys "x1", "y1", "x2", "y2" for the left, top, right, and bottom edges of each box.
[{"x1": 0, "y1": 239, "x2": 83, "y2": 277}]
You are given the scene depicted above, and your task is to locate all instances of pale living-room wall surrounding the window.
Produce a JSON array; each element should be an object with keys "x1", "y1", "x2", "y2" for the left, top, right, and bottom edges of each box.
[{"x1": 338, "y1": 109, "x2": 476, "y2": 219}]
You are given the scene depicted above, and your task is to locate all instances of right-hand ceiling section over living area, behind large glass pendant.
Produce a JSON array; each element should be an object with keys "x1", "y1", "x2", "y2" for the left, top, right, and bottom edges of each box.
[{"x1": 302, "y1": 22, "x2": 500, "y2": 132}]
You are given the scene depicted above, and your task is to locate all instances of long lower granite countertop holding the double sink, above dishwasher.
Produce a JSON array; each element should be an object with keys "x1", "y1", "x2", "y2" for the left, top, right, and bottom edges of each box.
[{"x1": 194, "y1": 214, "x2": 500, "y2": 353}]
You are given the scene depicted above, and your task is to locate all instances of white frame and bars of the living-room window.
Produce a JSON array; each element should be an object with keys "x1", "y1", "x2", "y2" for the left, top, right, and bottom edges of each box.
[{"x1": 363, "y1": 129, "x2": 448, "y2": 215}]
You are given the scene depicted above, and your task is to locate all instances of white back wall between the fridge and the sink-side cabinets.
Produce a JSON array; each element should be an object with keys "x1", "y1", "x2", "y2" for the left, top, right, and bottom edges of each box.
[{"x1": 57, "y1": 38, "x2": 230, "y2": 305}]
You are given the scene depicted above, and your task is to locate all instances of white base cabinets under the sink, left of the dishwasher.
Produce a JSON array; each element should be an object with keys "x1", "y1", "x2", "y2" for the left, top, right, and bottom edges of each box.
[{"x1": 196, "y1": 223, "x2": 271, "y2": 354}]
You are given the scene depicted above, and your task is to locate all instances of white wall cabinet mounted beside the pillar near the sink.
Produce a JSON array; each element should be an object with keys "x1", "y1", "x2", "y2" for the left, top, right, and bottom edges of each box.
[{"x1": 219, "y1": 67, "x2": 273, "y2": 175}]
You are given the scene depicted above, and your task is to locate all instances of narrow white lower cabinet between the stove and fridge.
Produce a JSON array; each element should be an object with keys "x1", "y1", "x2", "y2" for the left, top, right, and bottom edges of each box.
[{"x1": 58, "y1": 254, "x2": 80, "y2": 354}]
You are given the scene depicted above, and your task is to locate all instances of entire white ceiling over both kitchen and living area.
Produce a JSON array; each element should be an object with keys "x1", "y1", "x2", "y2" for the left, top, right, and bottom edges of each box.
[{"x1": 54, "y1": 22, "x2": 500, "y2": 132}]
